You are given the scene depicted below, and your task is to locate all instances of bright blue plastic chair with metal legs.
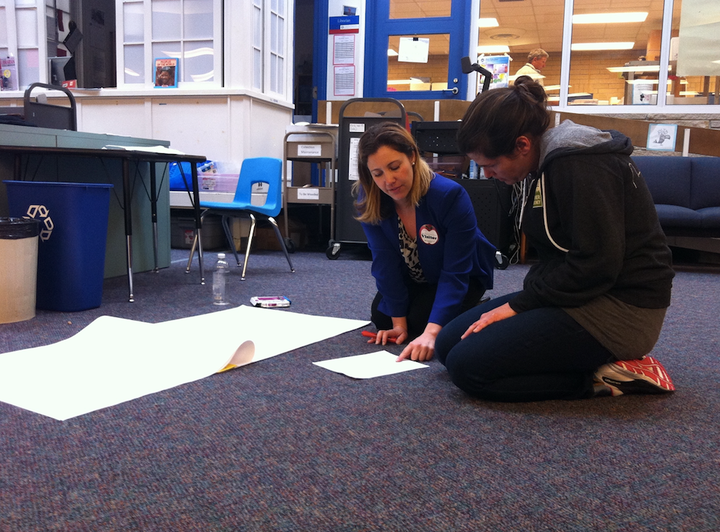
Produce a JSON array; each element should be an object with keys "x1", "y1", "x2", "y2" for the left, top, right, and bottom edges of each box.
[{"x1": 191, "y1": 157, "x2": 295, "y2": 281}]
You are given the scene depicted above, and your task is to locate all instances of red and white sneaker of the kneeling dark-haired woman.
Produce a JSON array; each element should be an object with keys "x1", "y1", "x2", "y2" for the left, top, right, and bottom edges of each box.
[{"x1": 595, "y1": 356, "x2": 675, "y2": 397}]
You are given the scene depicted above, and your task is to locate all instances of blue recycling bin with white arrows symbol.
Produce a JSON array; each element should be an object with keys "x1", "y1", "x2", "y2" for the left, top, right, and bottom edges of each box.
[{"x1": 4, "y1": 181, "x2": 112, "y2": 312}]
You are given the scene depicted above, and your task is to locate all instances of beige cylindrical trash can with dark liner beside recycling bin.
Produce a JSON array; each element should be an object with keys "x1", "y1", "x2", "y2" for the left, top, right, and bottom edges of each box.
[{"x1": 0, "y1": 218, "x2": 40, "y2": 323}]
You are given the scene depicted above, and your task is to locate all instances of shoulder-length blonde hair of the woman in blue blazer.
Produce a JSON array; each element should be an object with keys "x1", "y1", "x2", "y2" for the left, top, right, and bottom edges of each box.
[{"x1": 353, "y1": 122, "x2": 433, "y2": 224}]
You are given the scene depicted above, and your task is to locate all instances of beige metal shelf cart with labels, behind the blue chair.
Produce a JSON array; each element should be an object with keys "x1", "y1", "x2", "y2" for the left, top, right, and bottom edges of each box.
[{"x1": 283, "y1": 124, "x2": 337, "y2": 253}]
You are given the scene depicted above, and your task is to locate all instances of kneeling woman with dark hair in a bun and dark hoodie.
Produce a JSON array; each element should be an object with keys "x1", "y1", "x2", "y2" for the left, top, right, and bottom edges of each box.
[{"x1": 435, "y1": 77, "x2": 675, "y2": 401}]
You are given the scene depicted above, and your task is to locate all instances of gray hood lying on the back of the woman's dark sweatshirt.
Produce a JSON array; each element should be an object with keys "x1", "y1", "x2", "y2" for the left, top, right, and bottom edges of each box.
[{"x1": 540, "y1": 120, "x2": 633, "y2": 172}]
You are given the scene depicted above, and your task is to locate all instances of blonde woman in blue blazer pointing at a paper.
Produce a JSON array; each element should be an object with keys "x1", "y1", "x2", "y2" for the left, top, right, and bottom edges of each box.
[{"x1": 355, "y1": 122, "x2": 496, "y2": 360}]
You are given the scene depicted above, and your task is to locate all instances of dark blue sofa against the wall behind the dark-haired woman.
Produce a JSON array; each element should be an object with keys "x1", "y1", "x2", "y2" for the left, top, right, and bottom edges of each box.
[{"x1": 632, "y1": 155, "x2": 720, "y2": 237}]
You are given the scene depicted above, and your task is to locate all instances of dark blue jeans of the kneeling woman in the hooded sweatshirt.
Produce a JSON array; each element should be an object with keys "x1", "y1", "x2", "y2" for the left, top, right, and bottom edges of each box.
[{"x1": 435, "y1": 294, "x2": 614, "y2": 402}]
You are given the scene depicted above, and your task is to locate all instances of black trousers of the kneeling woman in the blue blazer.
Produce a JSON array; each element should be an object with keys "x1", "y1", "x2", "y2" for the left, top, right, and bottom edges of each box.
[{"x1": 370, "y1": 277, "x2": 485, "y2": 338}]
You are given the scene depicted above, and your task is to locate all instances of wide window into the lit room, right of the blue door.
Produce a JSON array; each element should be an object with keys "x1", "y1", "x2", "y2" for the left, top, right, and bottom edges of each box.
[{"x1": 478, "y1": 0, "x2": 720, "y2": 111}]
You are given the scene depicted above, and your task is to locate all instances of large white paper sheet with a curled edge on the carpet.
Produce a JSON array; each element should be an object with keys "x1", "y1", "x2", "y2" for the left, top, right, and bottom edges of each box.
[{"x1": 0, "y1": 306, "x2": 368, "y2": 421}]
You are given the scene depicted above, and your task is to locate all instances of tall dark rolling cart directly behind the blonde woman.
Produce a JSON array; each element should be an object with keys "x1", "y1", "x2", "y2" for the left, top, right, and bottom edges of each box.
[{"x1": 325, "y1": 98, "x2": 407, "y2": 260}]
